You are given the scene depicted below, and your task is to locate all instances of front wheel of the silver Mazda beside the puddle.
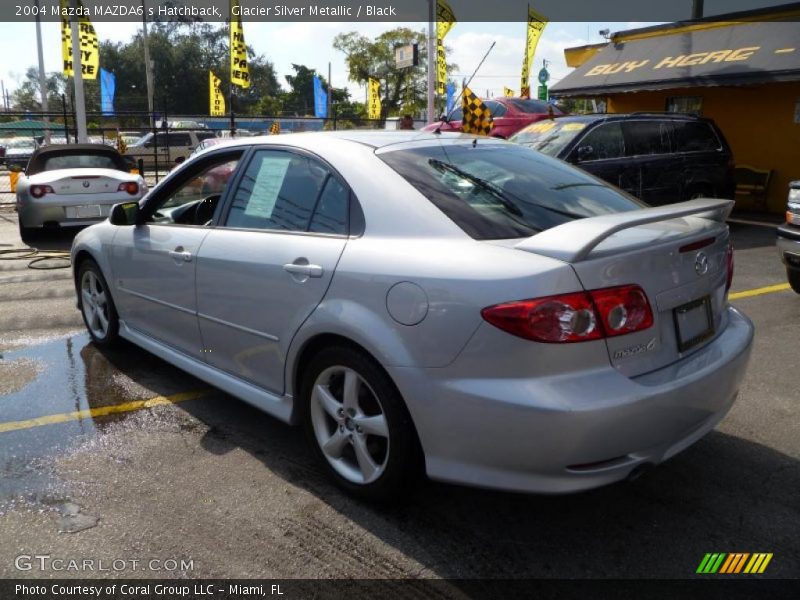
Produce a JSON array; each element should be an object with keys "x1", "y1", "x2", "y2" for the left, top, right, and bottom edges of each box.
[{"x1": 77, "y1": 259, "x2": 119, "y2": 347}]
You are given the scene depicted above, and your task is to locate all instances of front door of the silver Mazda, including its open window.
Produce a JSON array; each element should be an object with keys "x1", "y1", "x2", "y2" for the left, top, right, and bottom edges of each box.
[{"x1": 111, "y1": 150, "x2": 243, "y2": 358}]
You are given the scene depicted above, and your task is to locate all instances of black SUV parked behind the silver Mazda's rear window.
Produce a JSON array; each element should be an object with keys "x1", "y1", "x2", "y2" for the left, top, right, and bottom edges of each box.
[{"x1": 510, "y1": 113, "x2": 736, "y2": 205}]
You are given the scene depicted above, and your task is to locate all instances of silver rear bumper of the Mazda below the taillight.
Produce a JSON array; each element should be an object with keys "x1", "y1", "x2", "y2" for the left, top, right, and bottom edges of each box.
[{"x1": 389, "y1": 308, "x2": 753, "y2": 493}]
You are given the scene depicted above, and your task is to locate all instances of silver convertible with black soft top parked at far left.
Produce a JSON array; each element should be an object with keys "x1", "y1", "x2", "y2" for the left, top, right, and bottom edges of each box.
[{"x1": 17, "y1": 144, "x2": 147, "y2": 240}]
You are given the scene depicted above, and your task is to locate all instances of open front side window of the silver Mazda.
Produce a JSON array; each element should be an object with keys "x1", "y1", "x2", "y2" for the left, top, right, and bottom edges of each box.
[{"x1": 145, "y1": 151, "x2": 242, "y2": 225}]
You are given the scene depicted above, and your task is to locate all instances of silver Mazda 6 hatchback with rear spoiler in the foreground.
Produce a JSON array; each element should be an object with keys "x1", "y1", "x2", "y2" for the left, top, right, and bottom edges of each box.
[{"x1": 72, "y1": 132, "x2": 753, "y2": 499}]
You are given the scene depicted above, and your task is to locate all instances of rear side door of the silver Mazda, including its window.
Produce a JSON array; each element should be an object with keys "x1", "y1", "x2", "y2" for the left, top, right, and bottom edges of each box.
[{"x1": 197, "y1": 149, "x2": 350, "y2": 394}]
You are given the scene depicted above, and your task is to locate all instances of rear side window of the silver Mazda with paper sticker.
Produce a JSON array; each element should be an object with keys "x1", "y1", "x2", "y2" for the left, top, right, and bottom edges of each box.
[{"x1": 225, "y1": 150, "x2": 349, "y2": 234}]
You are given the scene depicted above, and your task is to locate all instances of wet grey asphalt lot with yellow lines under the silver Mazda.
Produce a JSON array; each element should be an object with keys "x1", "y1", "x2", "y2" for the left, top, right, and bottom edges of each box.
[{"x1": 0, "y1": 208, "x2": 800, "y2": 578}]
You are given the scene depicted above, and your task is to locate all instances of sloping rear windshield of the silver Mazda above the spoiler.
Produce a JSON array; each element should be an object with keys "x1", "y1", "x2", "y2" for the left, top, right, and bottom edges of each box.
[{"x1": 378, "y1": 140, "x2": 646, "y2": 240}]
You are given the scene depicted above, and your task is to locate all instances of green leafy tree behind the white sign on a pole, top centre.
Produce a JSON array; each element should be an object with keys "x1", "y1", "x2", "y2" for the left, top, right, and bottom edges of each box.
[{"x1": 333, "y1": 27, "x2": 458, "y2": 117}]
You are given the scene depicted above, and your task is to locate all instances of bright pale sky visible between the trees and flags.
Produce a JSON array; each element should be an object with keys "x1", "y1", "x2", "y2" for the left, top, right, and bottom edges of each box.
[{"x1": 0, "y1": 21, "x2": 650, "y2": 107}]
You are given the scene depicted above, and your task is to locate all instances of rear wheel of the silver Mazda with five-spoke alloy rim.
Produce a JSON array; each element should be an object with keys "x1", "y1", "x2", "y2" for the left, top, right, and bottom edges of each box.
[{"x1": 299, "y1": 346, "x2": 424, "y2": 502}]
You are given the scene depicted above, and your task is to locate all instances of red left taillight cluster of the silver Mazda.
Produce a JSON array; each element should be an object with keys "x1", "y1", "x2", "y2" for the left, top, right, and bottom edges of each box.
[{"x1": 481, "y1": 285, "x2": 653, "y2": 343}]
